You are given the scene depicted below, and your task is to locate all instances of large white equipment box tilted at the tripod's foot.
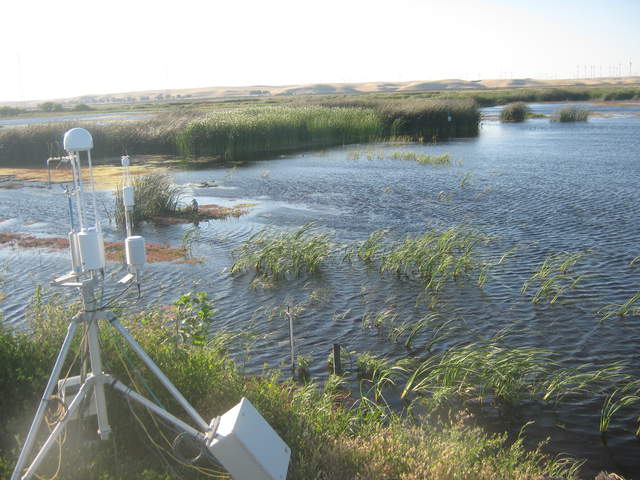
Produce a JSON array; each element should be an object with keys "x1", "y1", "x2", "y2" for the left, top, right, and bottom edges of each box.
[{"x1": 207, "y1": 398, "x2": 291, "y2": 480}]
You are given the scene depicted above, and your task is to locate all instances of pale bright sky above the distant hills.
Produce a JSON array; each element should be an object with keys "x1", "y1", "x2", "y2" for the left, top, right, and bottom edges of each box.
[{"x1": 0, "y1": 0, "x2": 640, "y2": 101}]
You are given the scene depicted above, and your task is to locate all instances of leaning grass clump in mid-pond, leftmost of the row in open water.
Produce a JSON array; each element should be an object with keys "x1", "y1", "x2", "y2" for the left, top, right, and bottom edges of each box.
[{"x1": 231, "y1": 222, "x2": 332, "y2": 280}]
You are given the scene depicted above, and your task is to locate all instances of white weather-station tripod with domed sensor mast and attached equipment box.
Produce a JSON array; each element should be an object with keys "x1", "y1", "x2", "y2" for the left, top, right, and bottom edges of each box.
[{"x1": 11, "y1": 128, "x2": 291, "y2": 480}]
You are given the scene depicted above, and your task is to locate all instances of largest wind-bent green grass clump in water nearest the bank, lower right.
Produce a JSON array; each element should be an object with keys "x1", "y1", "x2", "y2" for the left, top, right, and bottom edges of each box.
[{"x1": 402, "y1": 340, "x2": 625, "y2": 408}]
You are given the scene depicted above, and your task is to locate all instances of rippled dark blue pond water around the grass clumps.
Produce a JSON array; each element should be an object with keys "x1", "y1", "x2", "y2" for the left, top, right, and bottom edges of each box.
[{"x1": 0, "y1": 103, "x2": 640, "y2": 478}]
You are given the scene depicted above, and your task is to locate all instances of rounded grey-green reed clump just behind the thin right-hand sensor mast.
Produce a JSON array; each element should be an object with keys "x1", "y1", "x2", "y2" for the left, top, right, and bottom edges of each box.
[{"x1": 114, "y1": 173, "x2": 183, "y2": 228}]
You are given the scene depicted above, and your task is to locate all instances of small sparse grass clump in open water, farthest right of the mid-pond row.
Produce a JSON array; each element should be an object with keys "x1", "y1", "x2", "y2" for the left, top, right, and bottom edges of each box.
[{"x1": 520, "y1": 250, "x2": 590, "y2": 304}]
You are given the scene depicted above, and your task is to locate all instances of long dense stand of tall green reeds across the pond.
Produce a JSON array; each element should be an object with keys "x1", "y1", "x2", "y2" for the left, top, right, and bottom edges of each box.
[{"x1": 0, "y1": 100, "x2": 480, "y2": 166}]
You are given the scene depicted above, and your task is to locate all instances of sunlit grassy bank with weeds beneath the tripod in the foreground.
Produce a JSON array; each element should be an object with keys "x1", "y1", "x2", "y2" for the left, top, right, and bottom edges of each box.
[{"x1": 0, "y1": 294, "x2": 592, "y2": 480}]
